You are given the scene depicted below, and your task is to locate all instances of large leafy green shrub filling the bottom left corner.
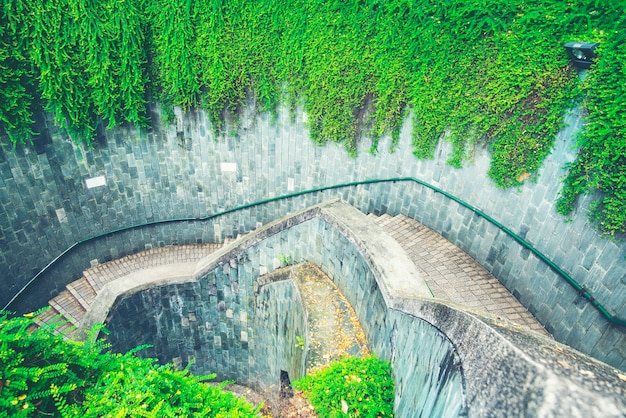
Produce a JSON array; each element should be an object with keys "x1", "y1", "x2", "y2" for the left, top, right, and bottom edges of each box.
[{"x1": 0, "y1": 312, "x2": 258, "y2": 417}]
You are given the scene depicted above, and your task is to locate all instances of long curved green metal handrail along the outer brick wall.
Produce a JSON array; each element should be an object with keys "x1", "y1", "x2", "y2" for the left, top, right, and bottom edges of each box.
[{"x1": 3, "y1": 177, "x2": 626, "y2": 327}]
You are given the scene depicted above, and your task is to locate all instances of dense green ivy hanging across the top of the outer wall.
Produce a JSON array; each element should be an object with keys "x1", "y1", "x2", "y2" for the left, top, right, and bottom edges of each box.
[{"x1": 0, "y1": 0, "x2": 626, "y2": 234}]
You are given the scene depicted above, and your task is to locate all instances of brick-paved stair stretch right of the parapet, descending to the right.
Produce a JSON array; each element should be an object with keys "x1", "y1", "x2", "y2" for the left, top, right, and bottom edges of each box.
[{"x1": 371, "y1": 214, "x2": 549, "y2": 335}]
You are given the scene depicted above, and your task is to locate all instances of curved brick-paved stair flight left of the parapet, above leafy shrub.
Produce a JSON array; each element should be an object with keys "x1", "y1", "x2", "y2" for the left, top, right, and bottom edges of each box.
[{"x1": 36, "y1": 244, "x2": 223, "y2": 333}]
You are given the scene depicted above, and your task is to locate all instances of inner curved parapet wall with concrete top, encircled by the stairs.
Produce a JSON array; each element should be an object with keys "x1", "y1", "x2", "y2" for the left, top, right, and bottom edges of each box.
[{"x1": 81, "y1": 201, "x2": 626, "y2": 418}]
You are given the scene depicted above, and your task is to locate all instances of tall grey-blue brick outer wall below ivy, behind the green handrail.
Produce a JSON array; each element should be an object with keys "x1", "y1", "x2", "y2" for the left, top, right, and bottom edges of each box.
[{"x1": 0, "y1": 103, "x2": 626, "y2": 370}]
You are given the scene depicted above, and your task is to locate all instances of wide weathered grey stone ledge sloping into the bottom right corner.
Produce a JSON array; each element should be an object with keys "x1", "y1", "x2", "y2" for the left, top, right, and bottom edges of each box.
[{"x1": 391, "y1": 298, "x2": 626, "y2": 417}]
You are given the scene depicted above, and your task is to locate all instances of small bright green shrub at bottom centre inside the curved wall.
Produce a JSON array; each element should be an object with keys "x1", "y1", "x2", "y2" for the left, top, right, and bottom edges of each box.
[{"x1": 294, "y1": 356, "x2": 394, "y2": 417}]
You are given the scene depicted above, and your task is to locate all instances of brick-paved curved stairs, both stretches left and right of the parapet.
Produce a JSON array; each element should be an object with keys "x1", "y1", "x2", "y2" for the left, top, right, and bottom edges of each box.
[{"x1": 37, "y1": 214, "x2": 549, "y2": 335}]
